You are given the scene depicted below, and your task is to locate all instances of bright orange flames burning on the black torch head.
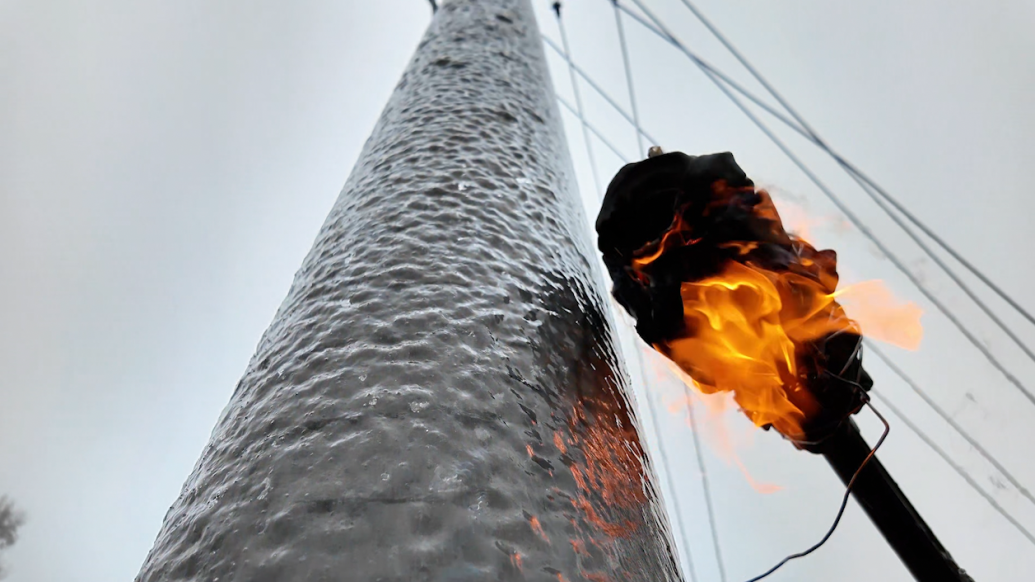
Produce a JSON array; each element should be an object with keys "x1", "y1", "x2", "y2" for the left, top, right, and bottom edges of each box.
[{"x1": 631, "y1": 188, "x2": 922, "y2": 439}]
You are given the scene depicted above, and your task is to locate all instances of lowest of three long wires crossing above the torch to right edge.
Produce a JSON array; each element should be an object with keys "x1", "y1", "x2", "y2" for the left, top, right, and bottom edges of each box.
[{"x1": 621, "y1": 0, "x2": 1035, "y2": 405}]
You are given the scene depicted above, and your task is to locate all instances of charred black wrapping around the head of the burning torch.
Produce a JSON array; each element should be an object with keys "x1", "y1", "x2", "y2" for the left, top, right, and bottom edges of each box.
[{"x1": 596, "y1": 152, "x2": 873, "y2": 448}]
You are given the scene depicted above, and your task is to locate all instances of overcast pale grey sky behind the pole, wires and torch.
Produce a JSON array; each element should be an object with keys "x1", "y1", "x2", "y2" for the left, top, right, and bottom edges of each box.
[{"x1": 0, "y1": 0, "x2": 1035, "y2": 582}]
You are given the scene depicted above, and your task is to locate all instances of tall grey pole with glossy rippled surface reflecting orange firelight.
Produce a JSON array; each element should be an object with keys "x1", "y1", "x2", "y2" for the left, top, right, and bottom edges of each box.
[{"x1": 138, "y1": 0, "x2": 680, "y2": 582}]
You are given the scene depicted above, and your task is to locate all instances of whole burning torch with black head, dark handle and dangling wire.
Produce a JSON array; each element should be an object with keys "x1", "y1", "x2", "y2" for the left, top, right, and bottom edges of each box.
[{"x1": 596, "y1": 148, "x2": 971, "y2": 582}]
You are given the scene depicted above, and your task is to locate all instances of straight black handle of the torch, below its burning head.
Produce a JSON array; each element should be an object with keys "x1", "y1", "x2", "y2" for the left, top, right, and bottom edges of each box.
[{"x1": 822, "y1": 419, "x2": 974, "y2": 582}]
